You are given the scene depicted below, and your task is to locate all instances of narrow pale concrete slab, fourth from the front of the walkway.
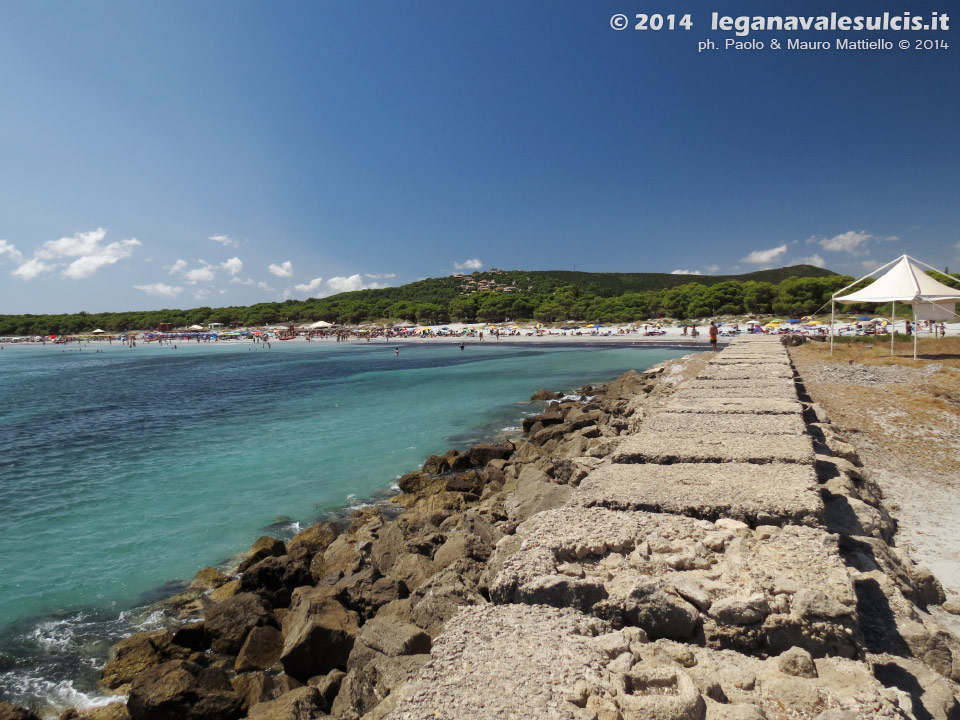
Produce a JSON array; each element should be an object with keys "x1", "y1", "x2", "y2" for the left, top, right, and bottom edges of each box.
[{"x1": 613, "y1": 431, "x2": 813, "y2": 465}]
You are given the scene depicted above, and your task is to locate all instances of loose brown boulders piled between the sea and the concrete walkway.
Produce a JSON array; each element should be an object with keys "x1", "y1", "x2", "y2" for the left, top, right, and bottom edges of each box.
[{"x1": 0, "y1": 354, "x2": 669, "y2": 720}]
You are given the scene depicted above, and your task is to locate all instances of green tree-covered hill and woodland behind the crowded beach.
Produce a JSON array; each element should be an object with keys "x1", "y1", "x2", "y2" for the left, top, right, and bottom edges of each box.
[{"x1": 0, "y1": 265, "x2": 936, "y2": 336}]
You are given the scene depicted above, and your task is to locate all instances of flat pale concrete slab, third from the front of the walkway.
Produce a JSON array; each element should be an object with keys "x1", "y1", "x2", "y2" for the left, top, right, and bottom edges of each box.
[{"x1": 571, "y1": 463, "x2": 823, "y2": 526}]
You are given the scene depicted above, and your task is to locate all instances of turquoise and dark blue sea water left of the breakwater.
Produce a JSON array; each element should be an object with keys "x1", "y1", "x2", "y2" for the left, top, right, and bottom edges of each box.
[{"x1": 0, "y1": 341, "x2": 689, "y2": 708}]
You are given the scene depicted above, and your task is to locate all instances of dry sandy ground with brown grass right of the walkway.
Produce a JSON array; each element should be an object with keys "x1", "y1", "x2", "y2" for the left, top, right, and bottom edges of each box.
[{"x1": 791, "y1": 337, "x2": 960, "y2": 597}]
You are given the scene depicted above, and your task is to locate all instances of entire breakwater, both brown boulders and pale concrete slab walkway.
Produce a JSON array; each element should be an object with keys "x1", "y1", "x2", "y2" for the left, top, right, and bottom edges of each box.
[{"x1": 0, "y1": 340, "x2": 960, "y2": 720}]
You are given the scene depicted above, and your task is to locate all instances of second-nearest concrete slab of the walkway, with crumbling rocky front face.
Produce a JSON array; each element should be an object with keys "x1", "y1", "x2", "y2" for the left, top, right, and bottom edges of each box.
[{"x1": 490, "y1": 507, "x2": 859, "y2": 657}]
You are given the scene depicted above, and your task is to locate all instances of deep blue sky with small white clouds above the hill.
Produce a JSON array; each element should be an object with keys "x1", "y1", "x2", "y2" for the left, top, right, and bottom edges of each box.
[{"x1": 0, "y1": 0, "x2": 960, "y2": 313}]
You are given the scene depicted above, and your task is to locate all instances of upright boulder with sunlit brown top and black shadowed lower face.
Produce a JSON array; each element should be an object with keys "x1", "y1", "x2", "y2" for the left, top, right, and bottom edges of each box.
[{"x1": 280, "y1": 588, "x2": 360, "y2": 682}]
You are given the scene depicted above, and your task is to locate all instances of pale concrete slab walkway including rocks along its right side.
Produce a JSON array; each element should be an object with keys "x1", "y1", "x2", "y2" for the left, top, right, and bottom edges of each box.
[{"x1": 366, "y1": 339, "x2": 960, "y2": 720}]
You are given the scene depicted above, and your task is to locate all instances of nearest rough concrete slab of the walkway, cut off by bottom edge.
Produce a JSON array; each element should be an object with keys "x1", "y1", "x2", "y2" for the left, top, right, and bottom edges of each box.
[{"x1": 376, "y1": 605, "x2": 910, "y2": 720}]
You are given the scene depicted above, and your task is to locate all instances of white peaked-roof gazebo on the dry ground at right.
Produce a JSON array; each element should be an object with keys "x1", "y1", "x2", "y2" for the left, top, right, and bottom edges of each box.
[{"x1": 830, "y1": 255, "x2": 960, "y2": 360}]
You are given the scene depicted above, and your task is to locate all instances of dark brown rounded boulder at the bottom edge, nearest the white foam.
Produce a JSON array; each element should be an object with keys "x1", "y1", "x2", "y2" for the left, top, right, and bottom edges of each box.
[{"x1": 127, "y1": 660, "x2": 243, "y2": 720}]
